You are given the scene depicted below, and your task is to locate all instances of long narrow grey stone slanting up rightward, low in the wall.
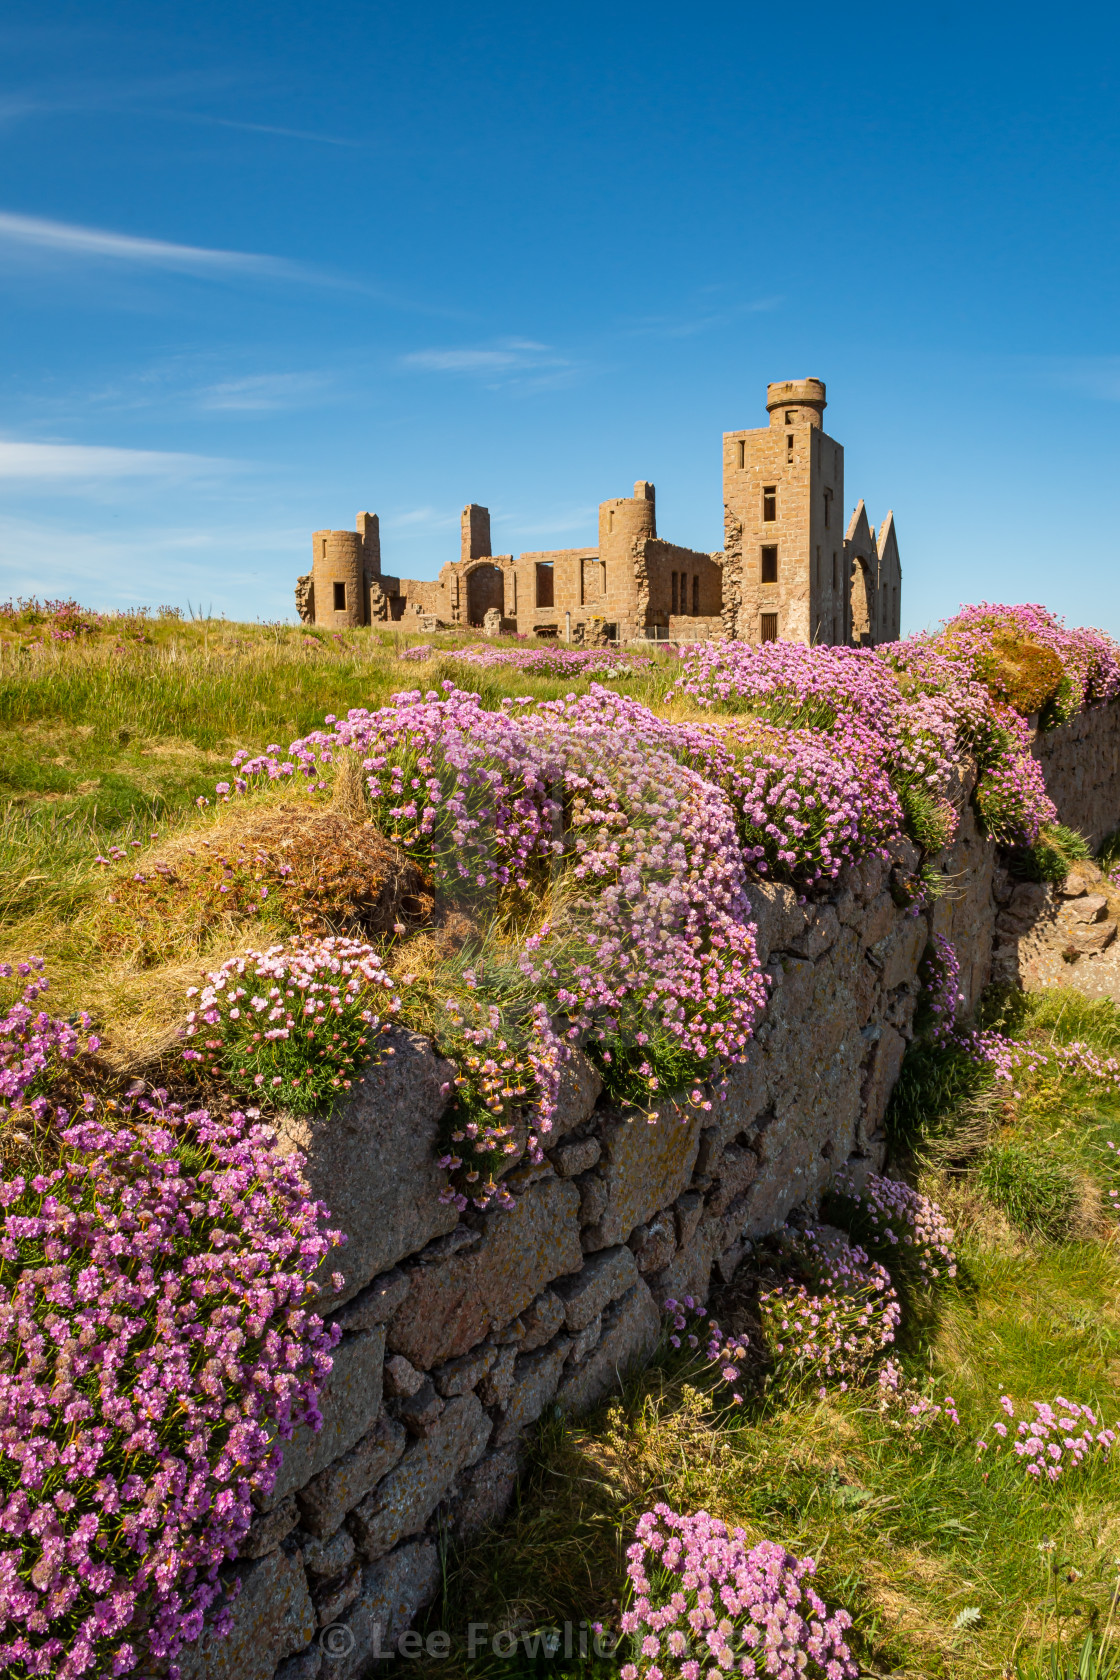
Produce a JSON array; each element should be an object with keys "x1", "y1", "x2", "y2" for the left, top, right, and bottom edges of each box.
[{"x1": 348, "y1": 1394, "x2": 490, "y2": 1562}]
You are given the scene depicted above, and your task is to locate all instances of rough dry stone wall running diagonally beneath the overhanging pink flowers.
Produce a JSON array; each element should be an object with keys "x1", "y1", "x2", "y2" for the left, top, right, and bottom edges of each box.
[{"x1": 183, "y1": 709, "x2": 1120, "y2": 1680}]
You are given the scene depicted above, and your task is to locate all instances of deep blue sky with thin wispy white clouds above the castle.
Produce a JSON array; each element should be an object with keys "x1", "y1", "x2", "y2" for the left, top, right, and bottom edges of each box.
[{"x1": 0, "y1": 0, "x2": 1120, "y2": 633}]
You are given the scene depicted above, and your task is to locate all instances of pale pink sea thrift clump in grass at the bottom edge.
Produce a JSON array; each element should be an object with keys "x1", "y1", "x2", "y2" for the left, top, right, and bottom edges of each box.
[{"x1": 620, "y1": 1504, "x2": 858, "y2": 1680}]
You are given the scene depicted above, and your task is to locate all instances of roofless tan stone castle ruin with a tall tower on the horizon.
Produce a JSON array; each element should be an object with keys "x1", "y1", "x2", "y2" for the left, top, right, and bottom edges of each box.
[{"x1": 296, "y1": 380, "x2": 902, "y2": 647}]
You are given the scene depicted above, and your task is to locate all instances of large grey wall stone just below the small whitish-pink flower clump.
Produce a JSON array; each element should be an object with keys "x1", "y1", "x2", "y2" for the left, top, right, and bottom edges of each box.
[{"x1": 277, "y1": 1028, "x2": 458, "y2": 1310}]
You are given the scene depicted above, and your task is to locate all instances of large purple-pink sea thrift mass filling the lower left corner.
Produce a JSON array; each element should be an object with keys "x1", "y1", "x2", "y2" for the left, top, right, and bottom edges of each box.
[{"x1": 0, "y1": 1023, "x2": 339, "y2": 1680}]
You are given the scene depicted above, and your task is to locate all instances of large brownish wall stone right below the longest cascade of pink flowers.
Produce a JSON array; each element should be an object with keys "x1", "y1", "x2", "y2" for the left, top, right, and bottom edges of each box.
[{"x1": 584, "y1": 1102, "x2": 704, "y2": 1250}]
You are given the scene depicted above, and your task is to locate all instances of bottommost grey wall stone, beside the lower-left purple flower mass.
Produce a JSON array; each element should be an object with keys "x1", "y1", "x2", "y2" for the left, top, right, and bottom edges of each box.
[{"x1": 180, "y1": 1542, "x2": 316, "y2": 1680}]
